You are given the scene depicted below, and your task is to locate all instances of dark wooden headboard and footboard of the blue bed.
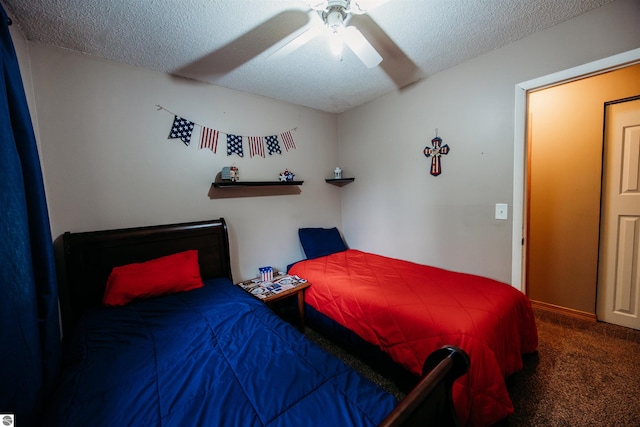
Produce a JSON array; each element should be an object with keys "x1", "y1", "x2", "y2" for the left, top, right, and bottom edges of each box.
[{"x1": 56, "y1": 218, "x2": 469, "y2": 427}]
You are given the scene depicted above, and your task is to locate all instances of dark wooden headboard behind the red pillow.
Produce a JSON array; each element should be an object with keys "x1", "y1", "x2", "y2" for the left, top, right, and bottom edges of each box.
[{"x1": 58, "y1": 218, "x2": 232, "y2": 332}]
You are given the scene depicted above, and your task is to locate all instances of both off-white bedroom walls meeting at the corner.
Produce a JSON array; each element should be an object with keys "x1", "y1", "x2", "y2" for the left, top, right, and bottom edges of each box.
[{"x1": 12, "y1": 0, "x2": 640, "y2": 288}]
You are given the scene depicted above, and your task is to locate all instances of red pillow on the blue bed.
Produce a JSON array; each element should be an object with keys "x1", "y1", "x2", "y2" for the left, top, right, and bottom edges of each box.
[{"x1": 102, "y1": 250, "x2": 204, "y2": 306}]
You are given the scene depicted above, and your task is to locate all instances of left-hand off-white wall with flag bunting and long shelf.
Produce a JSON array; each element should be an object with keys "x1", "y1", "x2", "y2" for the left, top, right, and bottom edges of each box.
[{"x1": 29, "y1": 43, "x2": 341, "y2": 280}]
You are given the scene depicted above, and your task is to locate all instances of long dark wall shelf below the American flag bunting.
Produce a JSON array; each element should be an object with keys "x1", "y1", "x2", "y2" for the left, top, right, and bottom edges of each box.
[{"x1": 209, "y1": 181, "x2": 304, "y2": 199}]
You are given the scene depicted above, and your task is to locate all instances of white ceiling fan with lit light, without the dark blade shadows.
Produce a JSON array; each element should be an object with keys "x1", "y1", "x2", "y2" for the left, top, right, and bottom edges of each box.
[{"x1": 272, "y1": 0, "x2": 388, "y2": 68}]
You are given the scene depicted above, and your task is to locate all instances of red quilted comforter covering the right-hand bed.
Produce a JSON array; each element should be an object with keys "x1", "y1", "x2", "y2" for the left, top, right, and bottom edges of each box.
[{"x1": 290, "y1": 249, "x2": 538, "y2": 426}]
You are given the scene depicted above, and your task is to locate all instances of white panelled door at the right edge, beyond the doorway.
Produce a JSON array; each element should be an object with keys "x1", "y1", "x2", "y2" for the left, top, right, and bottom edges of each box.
[{"x1": 597, "y1": 98, "x2": 640, "y2": 329}]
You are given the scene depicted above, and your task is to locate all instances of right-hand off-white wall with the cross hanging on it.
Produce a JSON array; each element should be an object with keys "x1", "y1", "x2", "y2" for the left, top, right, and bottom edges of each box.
[{"x1": 338, "y1": 0, "x2": 640, "y2": 282}]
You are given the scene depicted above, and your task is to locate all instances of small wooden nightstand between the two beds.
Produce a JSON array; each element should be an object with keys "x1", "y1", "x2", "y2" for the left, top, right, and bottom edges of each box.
[{"x1": 236, "y1": 274, "x2": 311, "y2": 333}]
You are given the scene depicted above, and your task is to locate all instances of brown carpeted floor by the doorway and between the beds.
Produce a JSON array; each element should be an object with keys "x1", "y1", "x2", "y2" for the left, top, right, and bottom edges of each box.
[{"x1": 306, "y1": 310, "x2": 640, "y2": 427}]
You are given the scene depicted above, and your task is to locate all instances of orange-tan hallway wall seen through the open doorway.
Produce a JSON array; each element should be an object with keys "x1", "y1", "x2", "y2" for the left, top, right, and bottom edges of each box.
[{"x1": 525, "y1": 64, "x2": 640, "y2": 318}]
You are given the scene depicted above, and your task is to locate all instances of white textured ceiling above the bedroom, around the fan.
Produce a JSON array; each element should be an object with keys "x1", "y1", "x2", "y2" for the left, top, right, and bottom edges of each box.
[{"x1": 2, "y1": 0, "x2": 612, "y2": 113}]
